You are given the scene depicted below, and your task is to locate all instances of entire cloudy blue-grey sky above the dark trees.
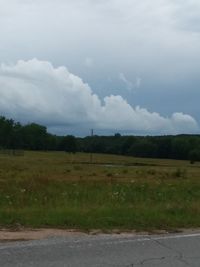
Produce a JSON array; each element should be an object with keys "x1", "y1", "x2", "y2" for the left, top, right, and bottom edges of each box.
[{"x1": 0, "y1": 0, "x2": 200, "y2": 136}]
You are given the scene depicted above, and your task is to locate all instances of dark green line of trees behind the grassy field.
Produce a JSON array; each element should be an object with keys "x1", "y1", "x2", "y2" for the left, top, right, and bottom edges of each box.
[{"x1": 0, "y1": 116, "x2": 200, "y2": 163}]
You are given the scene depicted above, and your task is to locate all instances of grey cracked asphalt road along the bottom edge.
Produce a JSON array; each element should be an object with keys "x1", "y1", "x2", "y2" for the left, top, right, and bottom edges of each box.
[{"x1": 0, "y1": 233, "x2": 200, "y2": 267}]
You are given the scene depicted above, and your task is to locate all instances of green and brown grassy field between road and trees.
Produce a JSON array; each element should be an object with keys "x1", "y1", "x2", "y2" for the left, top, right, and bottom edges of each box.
[{"x1": 0, "y1": 152, "x2": 200, "y2": 231}]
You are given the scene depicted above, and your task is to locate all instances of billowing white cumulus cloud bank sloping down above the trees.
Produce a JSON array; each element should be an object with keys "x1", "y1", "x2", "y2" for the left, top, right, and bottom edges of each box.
[{"x1": 0, "y1": 59, "x2": 199, "y2": 134}]
